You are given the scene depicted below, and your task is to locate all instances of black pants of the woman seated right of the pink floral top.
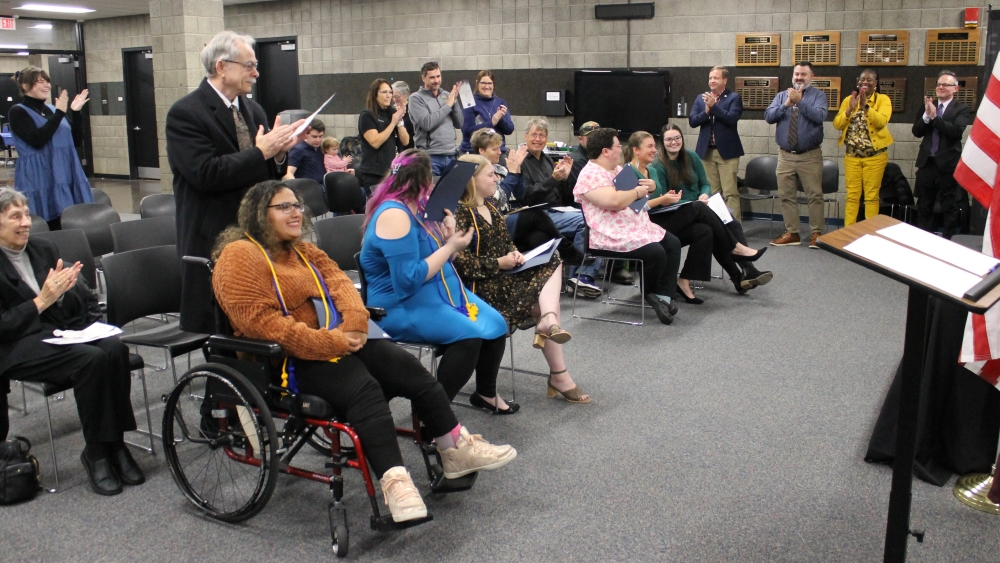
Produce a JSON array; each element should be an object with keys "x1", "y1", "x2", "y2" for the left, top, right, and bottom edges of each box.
[{"x1": 650, "y1": 201, "x2": 743, "y2": 280}]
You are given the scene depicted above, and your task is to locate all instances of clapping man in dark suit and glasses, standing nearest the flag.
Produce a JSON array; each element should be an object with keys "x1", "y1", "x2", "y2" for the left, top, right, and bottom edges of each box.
[{"x1": 913, "y1": 70, "x2": 975, "y2": 239}]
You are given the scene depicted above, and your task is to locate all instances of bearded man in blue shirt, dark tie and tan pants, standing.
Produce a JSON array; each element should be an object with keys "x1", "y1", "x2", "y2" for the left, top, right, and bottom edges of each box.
[{"x1": 764, "y1": 62, "x2": 829, "y2": 248}]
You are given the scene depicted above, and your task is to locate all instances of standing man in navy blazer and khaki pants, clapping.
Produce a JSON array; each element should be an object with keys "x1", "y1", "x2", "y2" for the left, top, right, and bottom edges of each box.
[{"x1": 688, "y1": 66, "x2": 743, "y2": 222}]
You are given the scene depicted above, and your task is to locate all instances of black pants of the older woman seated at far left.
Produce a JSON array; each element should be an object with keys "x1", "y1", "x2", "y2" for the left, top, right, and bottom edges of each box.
[{"x1": 0, "y1": 336, "x2": 136, "y2": 444}]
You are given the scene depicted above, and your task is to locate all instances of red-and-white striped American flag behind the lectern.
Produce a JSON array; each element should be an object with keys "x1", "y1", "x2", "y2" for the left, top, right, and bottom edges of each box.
[{"x1": 955, "y1": 58, "x2": 1000, "y2": 387}]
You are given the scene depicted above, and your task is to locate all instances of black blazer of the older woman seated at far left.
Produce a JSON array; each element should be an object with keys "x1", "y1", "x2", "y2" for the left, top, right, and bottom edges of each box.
[{"x1": 0, "y1": 239, "x2": 100, "y2": 376}]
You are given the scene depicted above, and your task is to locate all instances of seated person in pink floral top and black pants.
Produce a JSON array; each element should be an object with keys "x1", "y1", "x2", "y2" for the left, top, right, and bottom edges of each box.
[{"x1": 573, "y1": 127, "x2": 681, "y2": 324}]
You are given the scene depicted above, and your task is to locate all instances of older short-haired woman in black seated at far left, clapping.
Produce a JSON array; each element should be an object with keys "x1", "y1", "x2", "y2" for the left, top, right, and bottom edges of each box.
[{"x1": 0, "y1": 188, "x2": 146, "y2": 495}]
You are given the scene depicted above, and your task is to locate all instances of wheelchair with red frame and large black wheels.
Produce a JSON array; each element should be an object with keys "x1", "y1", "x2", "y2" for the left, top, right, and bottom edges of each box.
[{"x1": 162, "y1": 256, "x2": 478, "y2": 557}]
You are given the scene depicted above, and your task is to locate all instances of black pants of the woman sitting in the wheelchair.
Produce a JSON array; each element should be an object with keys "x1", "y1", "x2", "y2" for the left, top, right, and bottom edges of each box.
[{"x1": 294, "y1": 340, "x2": 458, "y2": 478}]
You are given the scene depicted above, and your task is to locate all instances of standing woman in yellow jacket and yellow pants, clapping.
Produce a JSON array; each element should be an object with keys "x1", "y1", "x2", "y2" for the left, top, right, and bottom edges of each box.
[{"x1": 833, "y1": 68, "x2": 892, "y2": 226}]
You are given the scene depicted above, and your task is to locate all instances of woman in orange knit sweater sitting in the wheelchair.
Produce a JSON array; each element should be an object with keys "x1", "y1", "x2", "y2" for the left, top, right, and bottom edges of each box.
[{"x1": 212, "y1": 181, "x2": 517, "y2": 522}]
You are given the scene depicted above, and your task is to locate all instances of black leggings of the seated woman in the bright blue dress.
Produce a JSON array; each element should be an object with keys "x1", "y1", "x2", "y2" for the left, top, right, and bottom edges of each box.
[{"x1": 438, "y1": 336, "x2": 507, "y2": 400}]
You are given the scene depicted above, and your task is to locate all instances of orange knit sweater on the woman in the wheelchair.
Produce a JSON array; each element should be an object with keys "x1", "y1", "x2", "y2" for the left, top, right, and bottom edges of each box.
[{"x1": 212, "y1": 240, "x2": 368, "y2": 361}]
